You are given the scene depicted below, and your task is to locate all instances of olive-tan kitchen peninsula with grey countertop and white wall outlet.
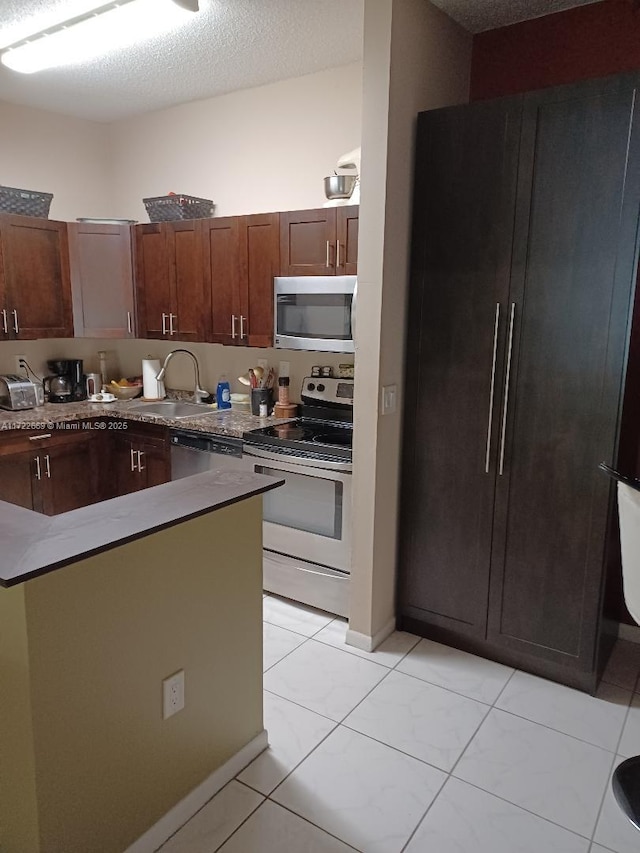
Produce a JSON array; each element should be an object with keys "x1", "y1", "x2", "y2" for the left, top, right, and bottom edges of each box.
[{"x1": 0, "y1": 466, "x2": 282, "y2": 853}]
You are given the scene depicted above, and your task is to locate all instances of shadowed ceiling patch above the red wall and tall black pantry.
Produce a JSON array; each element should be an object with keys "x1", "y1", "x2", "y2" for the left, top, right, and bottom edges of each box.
[{"x1": 432, "y1": 0, "x2": 599, "y2": 33}]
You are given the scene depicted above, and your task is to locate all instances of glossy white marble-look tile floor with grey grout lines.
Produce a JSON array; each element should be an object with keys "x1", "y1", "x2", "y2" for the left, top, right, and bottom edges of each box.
[{"x1": 161, "y1": 596, "x2": 640, "y2": 853}]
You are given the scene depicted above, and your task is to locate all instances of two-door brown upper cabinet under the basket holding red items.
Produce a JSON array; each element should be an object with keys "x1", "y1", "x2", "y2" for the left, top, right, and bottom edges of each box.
[{"x1": 135, "y1": 219, "x2": 211, "y2": 341}]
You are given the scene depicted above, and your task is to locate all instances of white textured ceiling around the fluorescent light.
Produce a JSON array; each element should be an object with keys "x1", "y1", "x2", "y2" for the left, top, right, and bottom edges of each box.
[{"x1": 0, "y1": 0, "x2": 364, "y2": 121}]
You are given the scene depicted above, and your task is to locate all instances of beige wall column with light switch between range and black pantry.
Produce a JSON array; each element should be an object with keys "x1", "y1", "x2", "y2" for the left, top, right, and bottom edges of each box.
[{"x1": 349, "y1": 0, "x2": 471, "y2": 641}]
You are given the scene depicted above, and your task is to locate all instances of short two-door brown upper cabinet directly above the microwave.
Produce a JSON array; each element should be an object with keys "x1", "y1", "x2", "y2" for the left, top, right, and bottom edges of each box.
[{"x1": 280, "y1": 205, "x2": 359, "y2": 276}]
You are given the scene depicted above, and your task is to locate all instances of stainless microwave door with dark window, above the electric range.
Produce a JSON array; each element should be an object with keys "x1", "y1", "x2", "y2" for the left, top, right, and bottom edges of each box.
[{"x1": 277, "y1": 293, "x2": 353, "y2": 341}]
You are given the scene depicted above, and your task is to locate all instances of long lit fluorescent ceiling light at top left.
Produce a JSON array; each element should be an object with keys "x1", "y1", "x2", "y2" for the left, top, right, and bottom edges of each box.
[{"x1": 0, "y1": 0, "x2": 198, "y2": 74}]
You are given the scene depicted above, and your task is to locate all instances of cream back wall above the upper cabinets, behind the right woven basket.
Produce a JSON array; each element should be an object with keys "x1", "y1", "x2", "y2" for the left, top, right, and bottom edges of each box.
[{"x1": 110, "y1": 63, "x2": 362, "y2": 222}]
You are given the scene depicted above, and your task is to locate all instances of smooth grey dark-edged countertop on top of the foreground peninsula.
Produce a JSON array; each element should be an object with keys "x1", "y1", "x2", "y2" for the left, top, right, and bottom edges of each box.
[{"x1": 0, "y1": 466, "x2": 284, "y2": 587}]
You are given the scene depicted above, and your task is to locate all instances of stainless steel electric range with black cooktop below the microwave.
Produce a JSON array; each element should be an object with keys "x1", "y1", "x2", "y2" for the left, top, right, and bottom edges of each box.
[{"x1": 243, "y1": 377, "x2": 353, "y2": 616}]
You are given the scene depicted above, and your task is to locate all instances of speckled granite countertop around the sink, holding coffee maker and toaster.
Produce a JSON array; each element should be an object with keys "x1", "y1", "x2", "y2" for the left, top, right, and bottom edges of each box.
[{"x1": 0, "y1": 400, "x2": 284, "y2": 438}]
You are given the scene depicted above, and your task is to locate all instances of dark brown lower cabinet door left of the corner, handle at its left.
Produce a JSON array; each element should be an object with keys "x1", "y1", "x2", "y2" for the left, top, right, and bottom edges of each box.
[{"x1": 39, "y1": 433, "x2": 100, "y2": 515}]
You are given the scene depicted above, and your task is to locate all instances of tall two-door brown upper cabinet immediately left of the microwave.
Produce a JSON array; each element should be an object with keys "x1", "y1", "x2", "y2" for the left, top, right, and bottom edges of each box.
[{"x1": 202, "y1": 213, "x2": 280, "y2": 347}]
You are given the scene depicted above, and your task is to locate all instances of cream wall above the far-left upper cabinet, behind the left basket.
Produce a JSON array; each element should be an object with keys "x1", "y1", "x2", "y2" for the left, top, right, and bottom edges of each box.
[{"x1": 0, "y1": 101, "x2": 113, "y2": 221}]
